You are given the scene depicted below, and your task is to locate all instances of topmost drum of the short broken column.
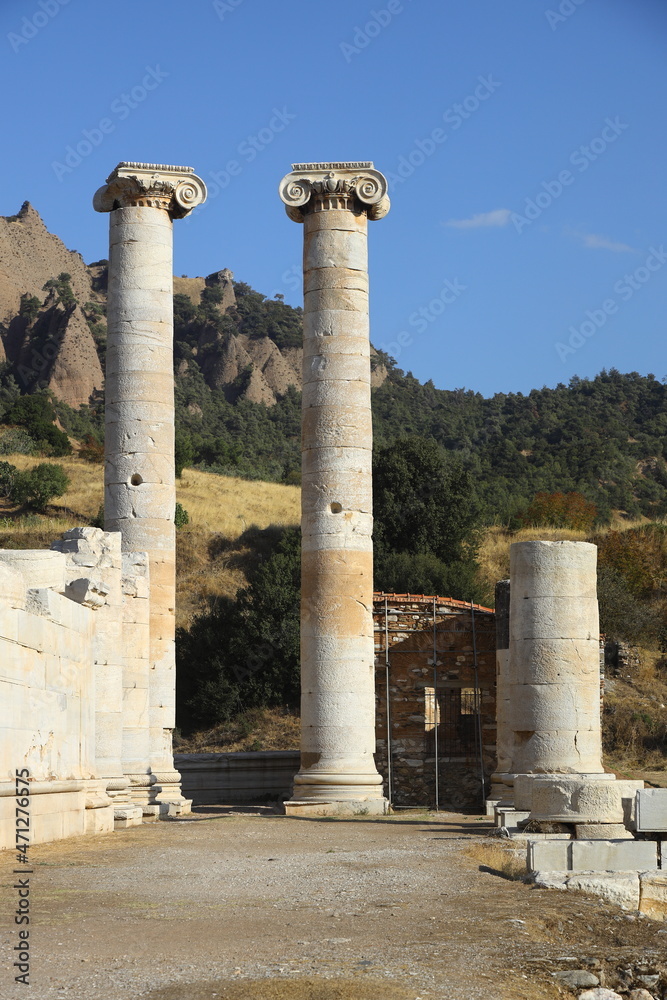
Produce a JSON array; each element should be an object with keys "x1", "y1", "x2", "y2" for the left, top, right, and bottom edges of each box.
[{"x1": 510, "y1": 541, "x2": 597, "y2": 601}]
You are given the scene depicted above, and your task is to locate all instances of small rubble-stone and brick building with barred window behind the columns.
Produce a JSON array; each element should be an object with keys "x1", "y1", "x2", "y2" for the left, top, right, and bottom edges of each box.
[{"x1": 374, "y1": 594, "x2": 496, "y2": 809}]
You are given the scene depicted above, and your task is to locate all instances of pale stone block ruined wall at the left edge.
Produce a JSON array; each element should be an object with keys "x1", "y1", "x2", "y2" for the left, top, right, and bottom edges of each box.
[{"x1": 0, "y1": 528, "x2": 155, "y2": 848}]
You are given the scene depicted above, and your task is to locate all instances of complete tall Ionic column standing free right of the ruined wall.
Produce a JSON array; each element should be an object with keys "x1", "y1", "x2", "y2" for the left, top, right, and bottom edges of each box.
[{"x1": 280, "y1": 163, "x2": 389, "y2": 815}]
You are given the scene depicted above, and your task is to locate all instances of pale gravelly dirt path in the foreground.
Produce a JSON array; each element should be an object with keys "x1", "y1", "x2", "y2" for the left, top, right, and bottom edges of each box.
[{"x1": 0, "y1": 809, "x2": 667, "y2": 1000}]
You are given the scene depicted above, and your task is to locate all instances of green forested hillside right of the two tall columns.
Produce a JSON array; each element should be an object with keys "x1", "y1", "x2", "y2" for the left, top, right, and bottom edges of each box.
[{"x1": 374, "y1": 369, "x2": 667, "y2": 520}]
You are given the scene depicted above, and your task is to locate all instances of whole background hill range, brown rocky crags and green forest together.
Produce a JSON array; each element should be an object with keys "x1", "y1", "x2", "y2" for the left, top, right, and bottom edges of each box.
[{"x1": 0, "y1": 202, "x2": 667, "y2": 521}]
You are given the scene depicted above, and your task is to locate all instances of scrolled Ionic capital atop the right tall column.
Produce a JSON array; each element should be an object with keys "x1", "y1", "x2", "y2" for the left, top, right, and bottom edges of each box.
[{"x1": 279, "y1": 161, "x2": 390, "y2": 222}]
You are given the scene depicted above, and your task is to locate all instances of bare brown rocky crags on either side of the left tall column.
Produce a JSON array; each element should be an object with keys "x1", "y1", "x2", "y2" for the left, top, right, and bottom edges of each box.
[{"x1": 0, "y1": 202, "x2": 382, "y2": 409}]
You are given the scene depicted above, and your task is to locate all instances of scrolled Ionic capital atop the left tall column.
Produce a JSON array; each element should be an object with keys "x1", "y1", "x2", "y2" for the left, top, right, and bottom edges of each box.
[{"x1": 93, "y1": 162, "x2": 206, "y2": 219}]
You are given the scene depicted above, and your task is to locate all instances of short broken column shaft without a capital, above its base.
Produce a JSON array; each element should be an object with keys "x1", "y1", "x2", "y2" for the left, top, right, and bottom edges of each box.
[{"x1": 509, "y1": 541, "x2": 603, "y2": 775}]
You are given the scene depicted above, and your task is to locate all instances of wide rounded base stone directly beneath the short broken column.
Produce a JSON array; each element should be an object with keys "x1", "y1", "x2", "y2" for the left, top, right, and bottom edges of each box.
[{"x1": 530, "y1": 777, "x2": 623, "y2": 824}]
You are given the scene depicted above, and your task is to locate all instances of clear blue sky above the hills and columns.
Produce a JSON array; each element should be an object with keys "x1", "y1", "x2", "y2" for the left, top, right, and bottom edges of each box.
[{"x1": 0, "y1": 0, "x2": 667, "y2": 395}]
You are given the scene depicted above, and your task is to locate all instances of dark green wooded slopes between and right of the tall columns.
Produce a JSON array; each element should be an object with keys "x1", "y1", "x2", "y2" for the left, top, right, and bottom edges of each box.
[{"x1": 176, "y1": 284, "x2": 667, "y2": 522}]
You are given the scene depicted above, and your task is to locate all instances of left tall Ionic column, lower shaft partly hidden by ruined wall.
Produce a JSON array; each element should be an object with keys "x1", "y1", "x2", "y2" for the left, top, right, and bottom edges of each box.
[{"x1": 94, "y1": 163, "x2": 206, "y2": 812}]
